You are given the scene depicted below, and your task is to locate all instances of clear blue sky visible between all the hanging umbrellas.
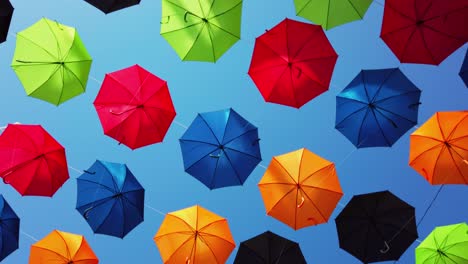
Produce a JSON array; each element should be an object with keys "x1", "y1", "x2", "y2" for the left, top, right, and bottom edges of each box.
[{"x1": 0, "y1": 0, "x2": 468, "y2": 264}]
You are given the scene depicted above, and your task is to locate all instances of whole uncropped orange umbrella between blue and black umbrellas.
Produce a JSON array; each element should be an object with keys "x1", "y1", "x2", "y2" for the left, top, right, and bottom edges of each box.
[{"x1": 258, "y1": 148, "x2": 343, "y2": 230}]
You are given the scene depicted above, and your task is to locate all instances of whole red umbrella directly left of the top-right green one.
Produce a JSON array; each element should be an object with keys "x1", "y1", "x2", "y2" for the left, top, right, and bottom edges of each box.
[{"x1": 249, "y1": 19, "x2": 338, "y2": 108}]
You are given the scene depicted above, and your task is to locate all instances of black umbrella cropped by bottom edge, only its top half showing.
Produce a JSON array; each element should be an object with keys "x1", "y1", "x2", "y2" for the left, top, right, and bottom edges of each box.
[{"x1": 234, "y1": 231, "x2": 307, "y2": 264}]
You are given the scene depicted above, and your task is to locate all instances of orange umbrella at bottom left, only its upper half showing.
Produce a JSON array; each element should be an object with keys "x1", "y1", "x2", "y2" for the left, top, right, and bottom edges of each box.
[{"x1": 29, "y1": 230, "x2": 99, "y2": 264}]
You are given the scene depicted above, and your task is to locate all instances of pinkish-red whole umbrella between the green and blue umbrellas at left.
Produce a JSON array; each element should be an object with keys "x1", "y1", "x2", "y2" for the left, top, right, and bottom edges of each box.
[{"x1": 94, "y1": 65, "x2": 176, "y2": 149}]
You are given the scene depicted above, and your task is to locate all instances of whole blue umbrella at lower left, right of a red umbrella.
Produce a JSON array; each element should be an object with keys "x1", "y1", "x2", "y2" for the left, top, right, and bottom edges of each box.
[{"x1": 76, "y1": 160, "x2": 145, "y2": 238}]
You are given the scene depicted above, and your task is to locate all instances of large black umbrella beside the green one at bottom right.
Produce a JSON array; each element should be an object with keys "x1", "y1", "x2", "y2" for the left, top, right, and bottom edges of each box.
[{"x1": 335, "y1": 191, "x2": 418, "y2": 263}]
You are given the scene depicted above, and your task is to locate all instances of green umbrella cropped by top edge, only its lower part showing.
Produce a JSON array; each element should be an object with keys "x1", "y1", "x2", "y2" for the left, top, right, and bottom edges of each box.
[{"x1": 294, "y1": 0, "x2": 373, "y2": 30}]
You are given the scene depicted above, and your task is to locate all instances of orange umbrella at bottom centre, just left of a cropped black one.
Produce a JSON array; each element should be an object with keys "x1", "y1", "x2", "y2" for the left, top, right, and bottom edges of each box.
[{"x1": 154, "y1": 205, "x2": 236, "y2": 264}]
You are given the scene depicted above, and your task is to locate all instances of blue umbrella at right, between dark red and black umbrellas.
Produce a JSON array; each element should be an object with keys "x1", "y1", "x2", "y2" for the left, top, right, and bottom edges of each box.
[{"x1": 335, "y1": 68, "x2": 421, "y2": 148}]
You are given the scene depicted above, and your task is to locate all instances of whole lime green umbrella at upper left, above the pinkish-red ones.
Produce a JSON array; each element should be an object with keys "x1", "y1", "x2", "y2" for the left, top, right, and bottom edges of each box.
[{"x1": 11, "y1": 18, "x2": 92, "y2": 105}]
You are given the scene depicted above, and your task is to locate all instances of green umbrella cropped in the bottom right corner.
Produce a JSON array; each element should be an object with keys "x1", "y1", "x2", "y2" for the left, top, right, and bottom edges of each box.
[{"x1": 416, "y1": 223, "x2": 468, "y2": 264}]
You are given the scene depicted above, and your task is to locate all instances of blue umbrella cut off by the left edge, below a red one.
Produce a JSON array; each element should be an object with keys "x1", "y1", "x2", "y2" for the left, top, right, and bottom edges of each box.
[{"x1": 0, "y1": 194, "x2": 19, "y2": 261}]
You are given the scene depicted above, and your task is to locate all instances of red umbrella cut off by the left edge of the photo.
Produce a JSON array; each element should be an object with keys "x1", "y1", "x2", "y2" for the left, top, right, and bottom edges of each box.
[{"x1": 0, "y1": 124, "x2": 69, "y2": 197}]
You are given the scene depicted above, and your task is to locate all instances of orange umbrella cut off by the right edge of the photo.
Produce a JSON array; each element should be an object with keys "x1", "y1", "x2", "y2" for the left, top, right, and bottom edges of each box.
[{"x1": 409, "y1": 111, "x2": 468, "y2": 185}]
